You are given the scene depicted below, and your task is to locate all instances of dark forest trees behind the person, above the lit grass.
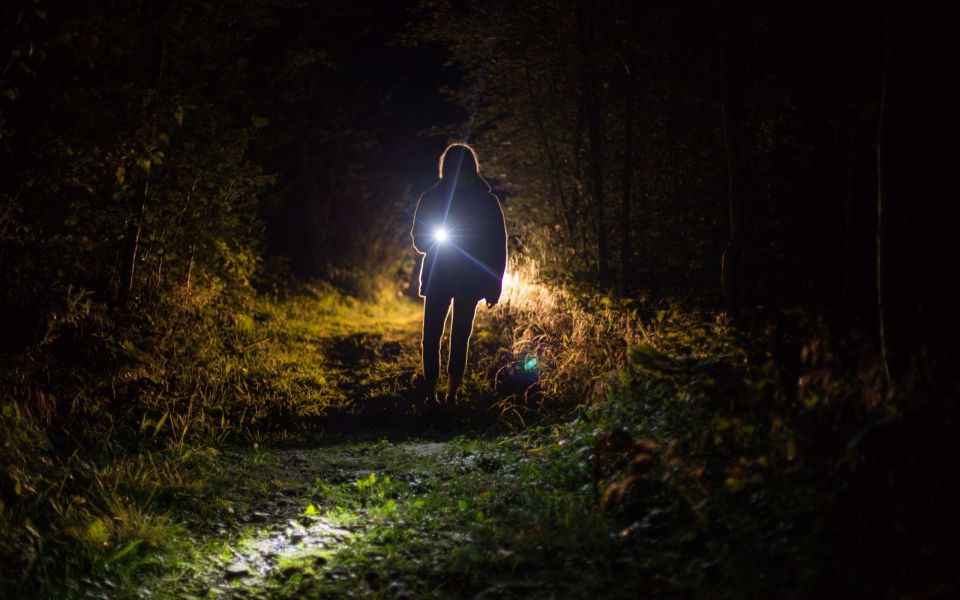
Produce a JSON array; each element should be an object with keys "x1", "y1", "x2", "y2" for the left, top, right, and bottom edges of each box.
[{"x1": 0, "y1": 0, "x2": 960, "y2": 369}]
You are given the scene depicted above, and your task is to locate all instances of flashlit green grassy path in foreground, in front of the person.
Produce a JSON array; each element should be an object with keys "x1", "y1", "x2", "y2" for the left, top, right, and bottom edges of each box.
[{"x1": 139, "y1": 434, "x2": 604, "y2": 598}]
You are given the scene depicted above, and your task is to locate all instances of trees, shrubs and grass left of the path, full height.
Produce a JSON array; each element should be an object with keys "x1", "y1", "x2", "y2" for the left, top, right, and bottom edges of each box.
[{"x1": 0, "y1": 0, "x2": 424, "y2": 594}]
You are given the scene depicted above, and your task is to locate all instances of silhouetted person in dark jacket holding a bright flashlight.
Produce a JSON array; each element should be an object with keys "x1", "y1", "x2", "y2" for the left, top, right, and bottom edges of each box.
[{"x1": 410, "y1": 142, "x2": 507, "y2": 402}]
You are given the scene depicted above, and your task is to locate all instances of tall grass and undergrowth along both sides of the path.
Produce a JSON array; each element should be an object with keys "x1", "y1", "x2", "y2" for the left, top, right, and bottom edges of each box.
[{"x1": 0, "y1": 260, "x2": 944, "y2": 595}]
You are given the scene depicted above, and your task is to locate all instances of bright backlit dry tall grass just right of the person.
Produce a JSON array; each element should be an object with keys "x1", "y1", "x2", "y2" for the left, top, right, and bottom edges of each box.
[{"x1": 478, "y1": 257, "x2": 735, "y2": 414}]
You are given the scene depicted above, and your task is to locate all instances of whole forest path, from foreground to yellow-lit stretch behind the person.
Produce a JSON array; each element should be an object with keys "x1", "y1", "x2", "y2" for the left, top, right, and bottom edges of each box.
[{"x1": 137, "y1": 301, "x2": 604, "y2": 598}]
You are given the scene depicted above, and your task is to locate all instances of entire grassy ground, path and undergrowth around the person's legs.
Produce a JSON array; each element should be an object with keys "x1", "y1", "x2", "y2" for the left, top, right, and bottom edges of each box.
[{"x1": 0, "y1": 265, "x2": 954, "y2": 598}]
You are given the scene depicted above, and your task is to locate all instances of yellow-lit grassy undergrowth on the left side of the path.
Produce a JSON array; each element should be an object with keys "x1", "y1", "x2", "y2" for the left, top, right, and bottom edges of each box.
[{"x1": 0, "y1": 284, "x2": 416, "y2": 593}]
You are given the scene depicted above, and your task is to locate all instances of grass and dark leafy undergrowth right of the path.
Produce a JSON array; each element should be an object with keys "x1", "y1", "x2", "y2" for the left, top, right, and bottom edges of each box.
[{"x1": 472, "y1": 265, "x2": 958, "y2": 596}]
